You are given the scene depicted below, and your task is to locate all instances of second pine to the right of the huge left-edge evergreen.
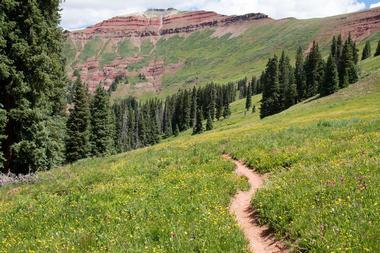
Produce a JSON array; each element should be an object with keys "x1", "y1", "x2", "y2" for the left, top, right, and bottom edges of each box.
[{"x1": 90, "y1": 85, "x2": 114, "y2": 156}]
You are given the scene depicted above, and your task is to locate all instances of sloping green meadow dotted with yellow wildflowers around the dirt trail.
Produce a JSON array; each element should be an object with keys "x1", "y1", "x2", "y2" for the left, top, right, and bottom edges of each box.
[{"x1": 0, "y1": 65, "x2": 380, "y2": 252}]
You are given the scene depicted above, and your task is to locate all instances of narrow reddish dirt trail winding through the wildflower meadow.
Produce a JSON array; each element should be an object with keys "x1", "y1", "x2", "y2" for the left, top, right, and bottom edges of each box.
[{"x1": 224, "y1": 155, "x2": 289, "y2": 253}]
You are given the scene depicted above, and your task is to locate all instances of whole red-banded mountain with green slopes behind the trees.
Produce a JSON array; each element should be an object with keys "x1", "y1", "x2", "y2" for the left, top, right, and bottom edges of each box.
[{"x1": 64, "y1": 8, "x2": 380, "y2": 97}]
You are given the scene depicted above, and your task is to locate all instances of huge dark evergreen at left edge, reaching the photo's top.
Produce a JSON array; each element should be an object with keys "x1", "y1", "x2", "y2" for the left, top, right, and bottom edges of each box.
[{"x1": 0, "y1": 0, "x2": 66, "y2": 174}]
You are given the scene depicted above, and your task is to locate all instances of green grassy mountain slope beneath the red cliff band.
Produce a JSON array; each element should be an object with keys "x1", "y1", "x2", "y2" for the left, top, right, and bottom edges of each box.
[{"x1": 65, "y1": 11, "x2": 380, "y2": 98}]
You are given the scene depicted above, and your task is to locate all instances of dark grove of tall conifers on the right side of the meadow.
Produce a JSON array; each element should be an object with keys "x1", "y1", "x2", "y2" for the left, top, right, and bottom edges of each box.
[{"x1": 260, "y1": 35, "x2": 368, "y2": 118}]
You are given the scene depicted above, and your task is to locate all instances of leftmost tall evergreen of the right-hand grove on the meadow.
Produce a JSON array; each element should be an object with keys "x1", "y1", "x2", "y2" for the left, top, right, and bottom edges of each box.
[{"x1": 260, "y1": 55, "x2": 281, "y2": 118}]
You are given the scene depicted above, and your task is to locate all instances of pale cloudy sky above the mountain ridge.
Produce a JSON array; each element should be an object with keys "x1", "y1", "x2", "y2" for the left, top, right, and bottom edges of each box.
[{"x1": 61, "y1": 0, "x2": 380, "y2": 30}]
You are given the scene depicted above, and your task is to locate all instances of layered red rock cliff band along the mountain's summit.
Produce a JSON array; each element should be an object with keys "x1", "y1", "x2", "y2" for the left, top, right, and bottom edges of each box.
[{"x1": 69, "y1": 10, "x2": 268, "y2": 40}]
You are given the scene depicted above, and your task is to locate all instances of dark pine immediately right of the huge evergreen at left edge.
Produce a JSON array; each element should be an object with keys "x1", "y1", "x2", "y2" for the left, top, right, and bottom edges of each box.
[{"x1": 66, "y1": 78, "x2": 91, "y2": 162}]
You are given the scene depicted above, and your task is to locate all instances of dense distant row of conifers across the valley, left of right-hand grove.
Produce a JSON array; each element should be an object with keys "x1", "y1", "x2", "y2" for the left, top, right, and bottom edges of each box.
[{"x1": 113, "y1": 83, "x2": 236, "y2": 152}]
